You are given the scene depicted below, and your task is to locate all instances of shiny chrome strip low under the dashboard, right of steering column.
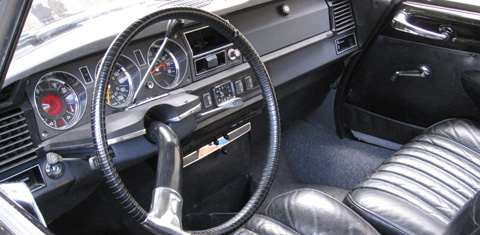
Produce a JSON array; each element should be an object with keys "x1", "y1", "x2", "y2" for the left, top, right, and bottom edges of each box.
[{"x1": 183, "y1": 123, "x2": 251, "y2": 168}]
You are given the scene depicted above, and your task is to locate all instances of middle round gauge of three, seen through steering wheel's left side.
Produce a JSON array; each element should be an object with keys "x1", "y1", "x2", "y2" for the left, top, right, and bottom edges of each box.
[{"x1": 95, "y1": 55, "x2": 140, "y2": 108}]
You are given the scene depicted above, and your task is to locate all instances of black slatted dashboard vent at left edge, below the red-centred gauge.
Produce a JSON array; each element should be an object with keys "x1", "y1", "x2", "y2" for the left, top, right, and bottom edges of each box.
[{"x1": 0, "y1": 108, "x2": 36, "y2": 172}]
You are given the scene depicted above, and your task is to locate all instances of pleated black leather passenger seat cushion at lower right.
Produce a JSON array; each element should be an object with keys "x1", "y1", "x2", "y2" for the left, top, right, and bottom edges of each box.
[{"x1": 345, "y1": 119, "x2": 480, "y2": 234}]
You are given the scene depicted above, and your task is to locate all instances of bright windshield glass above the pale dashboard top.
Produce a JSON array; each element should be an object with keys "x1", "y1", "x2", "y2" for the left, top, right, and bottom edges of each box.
[{"x1": 17, "y1": 0, "x2": 248, "y2": 50}]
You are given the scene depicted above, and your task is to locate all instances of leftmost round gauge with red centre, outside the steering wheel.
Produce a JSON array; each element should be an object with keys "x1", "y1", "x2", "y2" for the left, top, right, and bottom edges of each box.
[{"x1": 35, "y1": 72, "x2": 86, "y2": 130}]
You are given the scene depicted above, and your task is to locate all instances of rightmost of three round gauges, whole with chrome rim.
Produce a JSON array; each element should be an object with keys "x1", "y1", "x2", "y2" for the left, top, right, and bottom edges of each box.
[{"x1": 148, "y1": 39, "x2": 187, "y2": 89}]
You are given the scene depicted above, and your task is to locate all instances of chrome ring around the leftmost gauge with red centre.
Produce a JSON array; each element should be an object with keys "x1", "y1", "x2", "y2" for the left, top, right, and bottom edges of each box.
[{"x1": 33, "y1": 71, "x2": 88, "y2": 130}]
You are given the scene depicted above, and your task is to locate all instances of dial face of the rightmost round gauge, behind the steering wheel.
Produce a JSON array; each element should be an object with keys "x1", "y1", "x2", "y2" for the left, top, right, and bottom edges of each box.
[{"x1": 148, "y1": 40, "x2": 183, "y2": 89}]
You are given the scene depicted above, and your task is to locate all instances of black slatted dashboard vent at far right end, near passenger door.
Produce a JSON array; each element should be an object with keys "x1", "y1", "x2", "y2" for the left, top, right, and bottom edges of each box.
[{"x1": 328, "y1": 0, "x2": 355, "y2": 34}]
